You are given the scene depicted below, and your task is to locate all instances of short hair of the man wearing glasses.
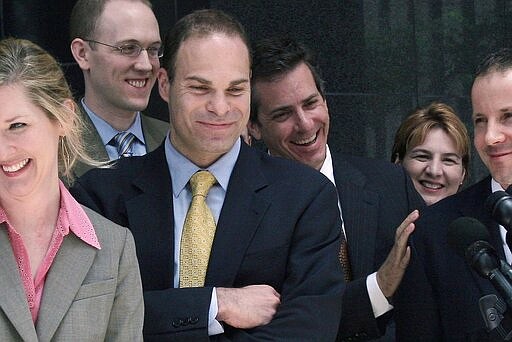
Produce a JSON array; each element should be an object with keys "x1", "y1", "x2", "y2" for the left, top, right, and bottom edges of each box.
[{"x1": 69, "y1": 0, "x2": 152, "y2": 40}]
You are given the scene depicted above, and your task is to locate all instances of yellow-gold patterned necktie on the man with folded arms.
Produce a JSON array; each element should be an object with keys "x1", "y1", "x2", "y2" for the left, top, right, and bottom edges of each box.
[{"x1": 180, "y1": 171, "x2": 217, "y2": 287}]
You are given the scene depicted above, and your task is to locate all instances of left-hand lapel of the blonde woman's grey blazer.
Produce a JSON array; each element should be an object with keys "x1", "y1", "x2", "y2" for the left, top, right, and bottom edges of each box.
[{"x1": 0, "y1": 225, "x2": 37, "y2": 341}]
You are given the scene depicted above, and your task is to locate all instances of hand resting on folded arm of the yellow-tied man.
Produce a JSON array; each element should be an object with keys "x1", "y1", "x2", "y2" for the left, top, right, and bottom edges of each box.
[{"x1": 217, "y1": 285, "x2": 281, "y2": 329}]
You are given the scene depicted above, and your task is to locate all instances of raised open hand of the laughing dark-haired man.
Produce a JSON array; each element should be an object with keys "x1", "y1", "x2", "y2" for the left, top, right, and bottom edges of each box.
[{"x1": 377, "y1": 210, "x2": 420, "y2": 298}]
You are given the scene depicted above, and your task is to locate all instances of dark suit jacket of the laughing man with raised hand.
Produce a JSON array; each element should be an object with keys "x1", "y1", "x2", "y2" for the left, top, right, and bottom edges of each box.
[{"x1": 332, "y1": 155, "x2": 424, "y2": 341}]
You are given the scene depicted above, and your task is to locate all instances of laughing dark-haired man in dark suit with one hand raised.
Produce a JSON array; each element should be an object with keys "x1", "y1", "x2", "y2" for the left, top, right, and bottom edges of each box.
[{"x1": 248, "y1": 38, "x2": 423, "y2": 341}]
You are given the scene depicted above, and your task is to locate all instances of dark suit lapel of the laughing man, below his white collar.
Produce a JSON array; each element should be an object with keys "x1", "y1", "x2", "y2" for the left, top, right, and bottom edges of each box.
[{"x1": 333, "y1": 156, "x2": 378, "y2": 278}]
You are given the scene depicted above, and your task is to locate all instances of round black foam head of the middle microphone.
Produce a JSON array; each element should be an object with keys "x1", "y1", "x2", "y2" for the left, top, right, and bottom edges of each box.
[{"x1": 447, "y1": 216, "x2": 489, "y2": 258}]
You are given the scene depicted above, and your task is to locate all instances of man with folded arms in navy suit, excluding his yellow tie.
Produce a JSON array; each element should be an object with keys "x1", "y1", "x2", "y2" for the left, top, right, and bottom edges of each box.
[{"x1": 72, "y1": 10, "x2": 344, "y2": 341}]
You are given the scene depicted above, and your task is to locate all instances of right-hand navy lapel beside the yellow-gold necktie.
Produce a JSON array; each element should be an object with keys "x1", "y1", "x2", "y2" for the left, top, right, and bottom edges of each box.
[{"x1": 205, "y1": 144, "x2": 270, "y2": 286}]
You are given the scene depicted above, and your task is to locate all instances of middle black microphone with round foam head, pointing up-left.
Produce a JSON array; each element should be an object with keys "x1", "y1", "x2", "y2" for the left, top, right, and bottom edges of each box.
[{"x1": 447, "y1": 217, "x2": 512, "y2": 309}]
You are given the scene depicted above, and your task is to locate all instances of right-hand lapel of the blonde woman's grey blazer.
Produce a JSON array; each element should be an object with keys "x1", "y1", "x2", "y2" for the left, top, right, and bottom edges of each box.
[{"x1": 36, "y1": 233, "x2": 96, "y2": 341}]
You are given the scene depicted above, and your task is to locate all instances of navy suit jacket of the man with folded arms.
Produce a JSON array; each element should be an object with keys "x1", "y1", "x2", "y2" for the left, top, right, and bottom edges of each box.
[{"x1": 72, "y1": 144, "x2": 344, "y2": 341}]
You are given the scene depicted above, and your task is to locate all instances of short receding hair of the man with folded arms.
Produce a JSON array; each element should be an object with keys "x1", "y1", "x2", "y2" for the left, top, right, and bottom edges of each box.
[{"x1": 160, "y1": 9, "x2": 251, "y2": 82}]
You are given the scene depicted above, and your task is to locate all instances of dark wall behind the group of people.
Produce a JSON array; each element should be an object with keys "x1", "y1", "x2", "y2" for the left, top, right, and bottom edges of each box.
[{"x1": 0, "y1": 0, "x2": 512, "y2": 182}]
